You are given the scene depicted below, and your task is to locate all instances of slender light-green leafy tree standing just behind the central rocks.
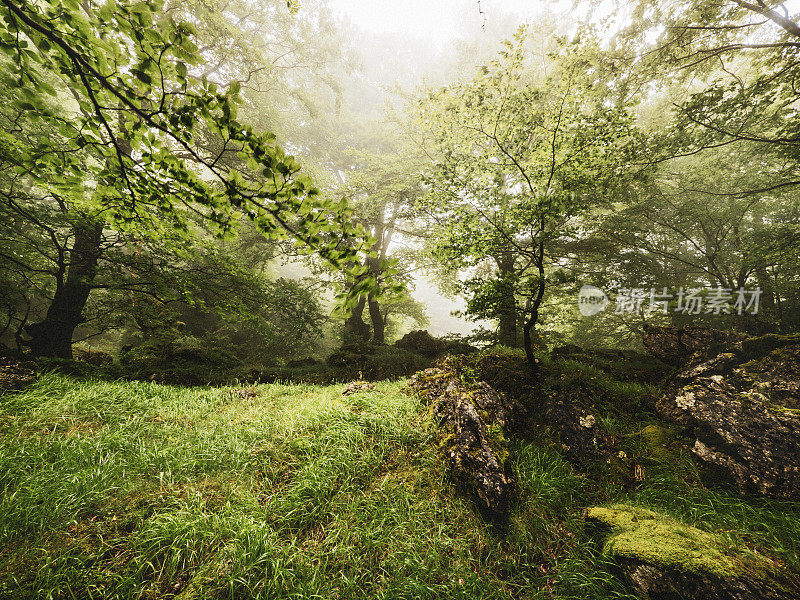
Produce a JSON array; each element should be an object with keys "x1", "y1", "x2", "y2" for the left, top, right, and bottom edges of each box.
[{"x1": 418, "y1": 30, "x2": 635, "y2": 372}]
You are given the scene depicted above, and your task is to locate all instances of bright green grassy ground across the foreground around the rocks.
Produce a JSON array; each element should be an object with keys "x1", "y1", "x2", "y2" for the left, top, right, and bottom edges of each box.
[{"x1": 0, "y1": 352, "x2": 800, "y2": 600}]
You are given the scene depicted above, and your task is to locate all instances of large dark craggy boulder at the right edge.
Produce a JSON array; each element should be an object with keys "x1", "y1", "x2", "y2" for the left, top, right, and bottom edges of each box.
[{"x1": 656, "y1": 336, "x2": 800, "y2": 500}]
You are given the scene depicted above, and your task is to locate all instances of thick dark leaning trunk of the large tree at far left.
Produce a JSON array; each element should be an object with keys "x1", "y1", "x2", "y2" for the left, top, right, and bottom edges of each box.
[{"x1": 25, "y1": 223, "x2": 103, "y2": 359}]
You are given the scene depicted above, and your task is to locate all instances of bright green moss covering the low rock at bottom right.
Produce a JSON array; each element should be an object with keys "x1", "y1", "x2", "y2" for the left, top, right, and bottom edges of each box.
[{"x1": 587, "y1": 504, "x2": 773, "y2": 578}]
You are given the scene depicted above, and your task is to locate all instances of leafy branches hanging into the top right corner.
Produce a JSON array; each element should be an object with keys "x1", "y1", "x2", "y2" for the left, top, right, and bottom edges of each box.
[{"x1": 609, "y1": 0, "x2": 800, "y2": 183}]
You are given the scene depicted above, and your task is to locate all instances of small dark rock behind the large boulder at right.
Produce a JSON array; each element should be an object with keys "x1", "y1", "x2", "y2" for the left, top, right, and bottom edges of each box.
[{"x1": 642, "y1": 324, "x2": 742, "y2": 366}]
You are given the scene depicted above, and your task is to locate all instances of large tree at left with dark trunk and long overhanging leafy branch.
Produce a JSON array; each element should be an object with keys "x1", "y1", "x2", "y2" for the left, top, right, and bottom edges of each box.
[{"x1": 0, "y1": 0, "x2": 372, "y2": 356}]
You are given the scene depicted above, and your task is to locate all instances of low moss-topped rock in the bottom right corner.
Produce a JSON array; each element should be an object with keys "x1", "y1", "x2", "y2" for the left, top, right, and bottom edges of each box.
[{"x1": 586, "y1": 504, "x2": 800, "y2": 600}]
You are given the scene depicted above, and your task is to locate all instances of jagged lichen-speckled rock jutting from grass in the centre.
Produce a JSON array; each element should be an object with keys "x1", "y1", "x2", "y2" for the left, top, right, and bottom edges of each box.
[{"x1": 408, "y1": 359, "x2": 524, "y2": 520}]
